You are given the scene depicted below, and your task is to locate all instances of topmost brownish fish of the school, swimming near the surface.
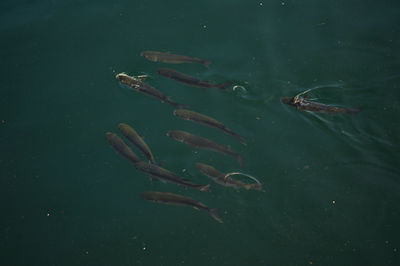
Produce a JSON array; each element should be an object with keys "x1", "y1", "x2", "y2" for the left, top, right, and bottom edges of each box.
[{"x1": 140, "y1": 51, "x2": 211, "y2": 67}]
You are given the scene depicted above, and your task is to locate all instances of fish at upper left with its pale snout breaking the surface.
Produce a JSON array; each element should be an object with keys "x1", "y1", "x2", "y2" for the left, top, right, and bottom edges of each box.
[{"x1": 115, "y1": 73, "x2": 188, "y2": 108}]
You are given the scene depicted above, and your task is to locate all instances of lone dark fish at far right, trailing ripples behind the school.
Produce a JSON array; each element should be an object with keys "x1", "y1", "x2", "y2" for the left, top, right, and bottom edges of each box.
[{"x1": 281, "y1": 97, "x2": 361, "y2": 114}]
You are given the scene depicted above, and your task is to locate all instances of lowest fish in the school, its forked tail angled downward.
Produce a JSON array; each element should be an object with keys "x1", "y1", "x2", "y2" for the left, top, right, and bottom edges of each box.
[{"x1": 140, "y1": 191, "x2": 223, "y2": 223}]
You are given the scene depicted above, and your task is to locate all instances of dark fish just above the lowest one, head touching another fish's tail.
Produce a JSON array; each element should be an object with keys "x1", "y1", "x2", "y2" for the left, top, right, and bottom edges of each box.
[{"x1": 135, "y1": 162, "x2": 210, "y2": 192}]
